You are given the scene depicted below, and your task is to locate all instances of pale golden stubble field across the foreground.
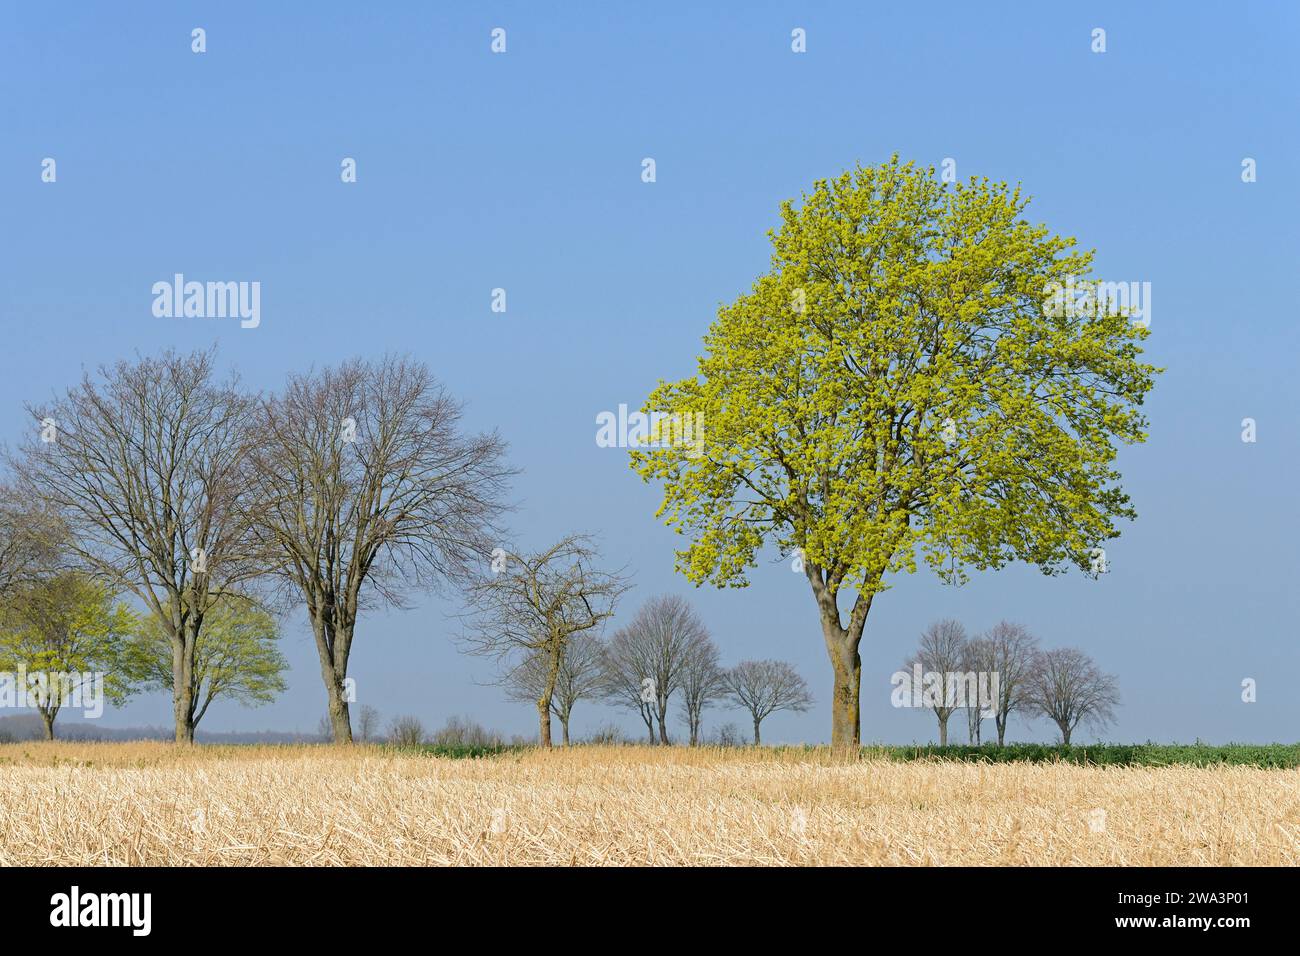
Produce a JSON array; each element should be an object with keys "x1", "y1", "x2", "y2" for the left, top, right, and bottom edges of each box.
[{"x1": 0, "y1": 743, "x2": 1300, "y2": 866}]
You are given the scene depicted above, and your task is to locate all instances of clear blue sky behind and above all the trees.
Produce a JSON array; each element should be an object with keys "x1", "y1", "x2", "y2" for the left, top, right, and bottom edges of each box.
[{"x1": 0, "y1": 1, "x2": 1300, "y2": 743}]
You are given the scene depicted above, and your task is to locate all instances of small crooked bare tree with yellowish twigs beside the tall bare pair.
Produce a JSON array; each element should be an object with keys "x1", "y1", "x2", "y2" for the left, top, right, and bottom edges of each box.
[{"x1": 464, "y1": 535, "x2": 628, "y2": 747}]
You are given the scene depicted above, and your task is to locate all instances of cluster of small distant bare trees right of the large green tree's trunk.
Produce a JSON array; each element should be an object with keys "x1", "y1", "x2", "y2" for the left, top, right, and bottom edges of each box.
[{"x1": 904, "y1": 619, "x2": 1119, "y2": 747}]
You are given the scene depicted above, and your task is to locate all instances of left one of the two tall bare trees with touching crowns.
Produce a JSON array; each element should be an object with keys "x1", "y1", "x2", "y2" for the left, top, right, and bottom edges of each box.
[{"x1": 14, "y1": 350, "x2": 264, "y2": 743}]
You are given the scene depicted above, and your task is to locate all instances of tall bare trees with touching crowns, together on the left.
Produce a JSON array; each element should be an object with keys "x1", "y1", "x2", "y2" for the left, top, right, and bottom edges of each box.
[{"x1": 0, "y1": 350, "x2": 512, "y2": 743}]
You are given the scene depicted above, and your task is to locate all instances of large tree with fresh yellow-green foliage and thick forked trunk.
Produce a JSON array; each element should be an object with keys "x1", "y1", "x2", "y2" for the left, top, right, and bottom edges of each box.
[{"x1": 632, "y1": 157, "x2": 1158, "y2": 747}]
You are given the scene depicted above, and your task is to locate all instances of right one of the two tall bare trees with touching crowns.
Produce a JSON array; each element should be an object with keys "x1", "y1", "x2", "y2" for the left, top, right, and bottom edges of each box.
[{"x1": 247, "y1": 356, "x2": 512, "y2": 743}]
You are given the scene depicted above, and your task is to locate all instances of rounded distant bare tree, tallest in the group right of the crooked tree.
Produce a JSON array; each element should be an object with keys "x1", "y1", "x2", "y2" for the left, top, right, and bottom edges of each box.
[{"x1": 606, "y1": 594, "x2": 710, "y2": 745}]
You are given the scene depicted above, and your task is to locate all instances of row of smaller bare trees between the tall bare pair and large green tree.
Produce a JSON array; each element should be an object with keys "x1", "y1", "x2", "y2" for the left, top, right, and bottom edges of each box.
[{"x1": 463, "y1": 546, "x2": 811, "y2": 747}]
